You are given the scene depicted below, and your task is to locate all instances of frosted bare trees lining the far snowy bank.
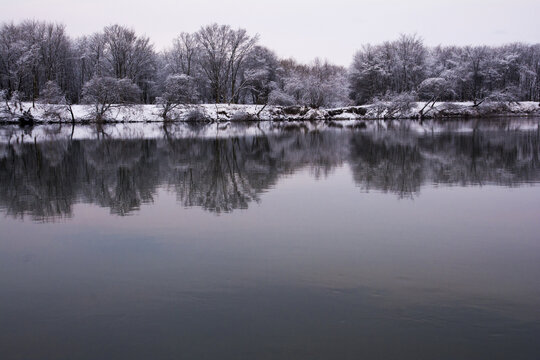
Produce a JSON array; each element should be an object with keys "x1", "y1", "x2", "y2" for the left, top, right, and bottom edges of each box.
[{"x1": 0, "y1": 20, "x2": 540, "y2": 109}]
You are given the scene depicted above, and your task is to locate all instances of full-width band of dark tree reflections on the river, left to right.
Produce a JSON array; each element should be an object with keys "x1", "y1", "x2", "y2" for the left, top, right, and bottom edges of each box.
[{"x1": 0, "y1": 123, "x2": 540, "y2": 221}]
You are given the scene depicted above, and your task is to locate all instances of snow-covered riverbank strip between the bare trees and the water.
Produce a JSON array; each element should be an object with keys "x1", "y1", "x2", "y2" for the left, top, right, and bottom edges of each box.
[{"x1": 0, "y1": 102, "x2": 540, "y2": 123}]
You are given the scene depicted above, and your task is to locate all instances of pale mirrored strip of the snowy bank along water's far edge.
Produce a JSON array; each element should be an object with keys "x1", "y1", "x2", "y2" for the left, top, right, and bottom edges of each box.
[{"x1": 0, "y1": 117, "x2": 540, "y2": 143}]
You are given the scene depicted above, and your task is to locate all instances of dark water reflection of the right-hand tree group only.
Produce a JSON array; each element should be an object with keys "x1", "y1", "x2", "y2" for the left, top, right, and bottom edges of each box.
[{"x1": 349, "y1": 130, "x2": 540, "y2": 197}]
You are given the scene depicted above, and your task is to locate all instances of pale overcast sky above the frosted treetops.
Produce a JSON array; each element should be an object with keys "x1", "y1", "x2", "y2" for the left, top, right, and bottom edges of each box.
[{"x1": 0, "y1": 0, "x2": 540, "y2": 65}]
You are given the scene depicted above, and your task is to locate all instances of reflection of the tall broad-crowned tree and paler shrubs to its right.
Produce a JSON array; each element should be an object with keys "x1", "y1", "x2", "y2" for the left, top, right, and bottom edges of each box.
[{"x1": 166, "y1": 133, "x2": 346, "y2": 212}]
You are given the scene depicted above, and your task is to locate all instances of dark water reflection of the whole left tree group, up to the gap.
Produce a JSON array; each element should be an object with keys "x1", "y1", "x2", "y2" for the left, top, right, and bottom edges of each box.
[{"x1": 0, "y1": 133, "x2": 343, "y2": 220}]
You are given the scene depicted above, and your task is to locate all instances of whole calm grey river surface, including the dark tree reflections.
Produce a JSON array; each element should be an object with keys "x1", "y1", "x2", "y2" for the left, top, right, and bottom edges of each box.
[{"x1": 0, "y1": 121, "x2": 540, "y2": 360}]
